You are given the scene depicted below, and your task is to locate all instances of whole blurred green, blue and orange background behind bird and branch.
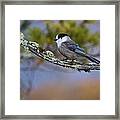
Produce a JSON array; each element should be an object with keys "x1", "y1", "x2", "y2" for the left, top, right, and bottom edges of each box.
[{"x1": 20, "y1": 20, "x2": 100, "y2": 100}]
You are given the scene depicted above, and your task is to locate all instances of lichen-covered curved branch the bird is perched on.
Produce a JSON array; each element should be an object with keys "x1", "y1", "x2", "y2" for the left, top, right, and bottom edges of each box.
[{"x1": 20, "y1": 33, "x2": 100, "y2": 72}]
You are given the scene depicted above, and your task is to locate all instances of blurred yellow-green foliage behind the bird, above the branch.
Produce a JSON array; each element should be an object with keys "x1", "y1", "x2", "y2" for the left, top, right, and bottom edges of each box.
[{"x1": 21, "y1": 20, "x2": 100, "y2": 51}]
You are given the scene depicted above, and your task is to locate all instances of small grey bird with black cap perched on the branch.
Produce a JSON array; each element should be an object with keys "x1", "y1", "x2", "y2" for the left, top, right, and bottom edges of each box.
[{"x1": 54, "y1": 33, "x2": 100, "y2": 64}]
